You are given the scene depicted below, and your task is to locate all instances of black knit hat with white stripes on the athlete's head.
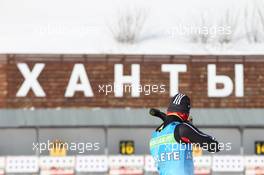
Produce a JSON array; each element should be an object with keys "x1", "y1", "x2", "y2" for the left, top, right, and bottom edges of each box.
[{"x1": 167, "y1": 93, "x2": 191, "y2": 114}]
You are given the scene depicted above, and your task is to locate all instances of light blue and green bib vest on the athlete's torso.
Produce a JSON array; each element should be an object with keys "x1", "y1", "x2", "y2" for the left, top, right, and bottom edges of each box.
[{"x1": 150, "y1": 122, "x2": 194, "y2": 175}]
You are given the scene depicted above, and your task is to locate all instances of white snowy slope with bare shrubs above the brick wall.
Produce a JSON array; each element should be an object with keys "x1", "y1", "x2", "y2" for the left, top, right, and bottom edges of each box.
[{"x1": 0, "y1": 0, "x2": 264, "y2": 54}]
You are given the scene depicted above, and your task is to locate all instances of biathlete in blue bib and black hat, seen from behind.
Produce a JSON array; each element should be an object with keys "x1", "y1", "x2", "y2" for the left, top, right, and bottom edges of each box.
[{"x1": 150, "y1": 93, "x2": 219, "y2": 175}]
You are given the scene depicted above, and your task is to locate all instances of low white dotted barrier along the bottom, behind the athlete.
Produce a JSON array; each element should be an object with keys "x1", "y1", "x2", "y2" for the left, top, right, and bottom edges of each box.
[{"x1": 0, "y1": 155, "x2": 264, "y2": 175}]
